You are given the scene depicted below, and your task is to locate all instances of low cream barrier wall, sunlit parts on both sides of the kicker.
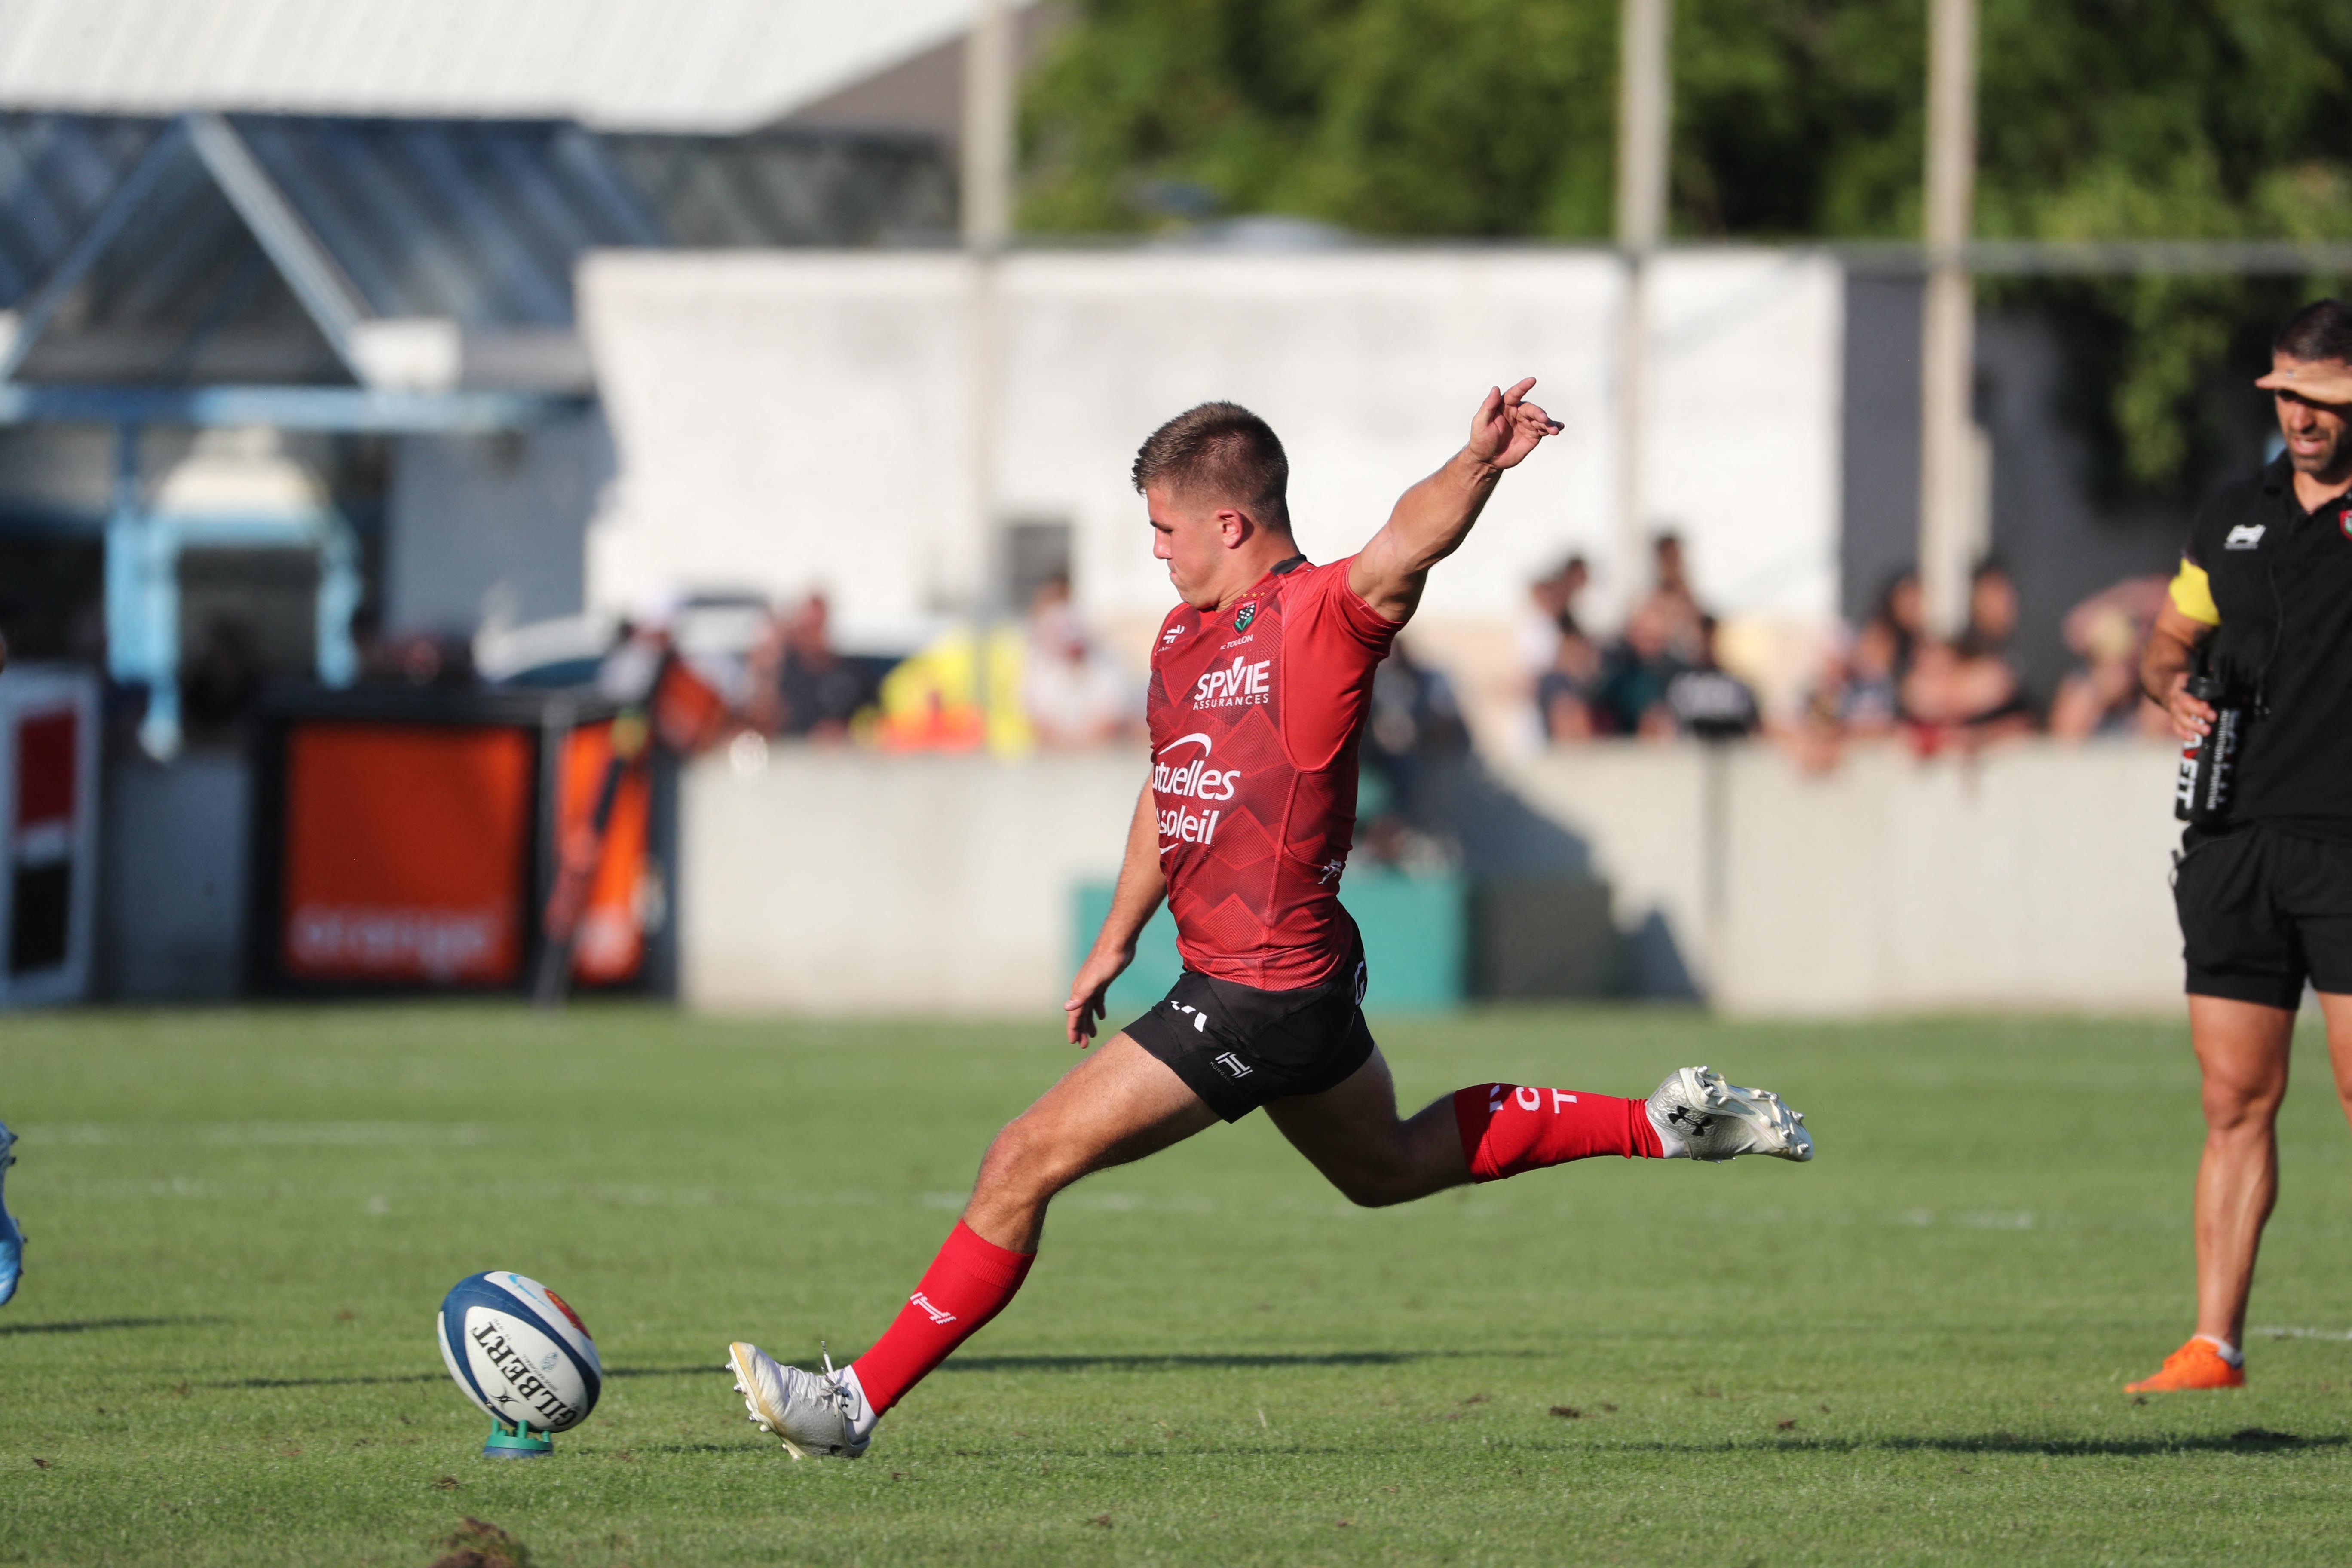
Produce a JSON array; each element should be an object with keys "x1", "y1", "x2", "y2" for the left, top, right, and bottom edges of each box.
[{"x1": 680, "y1": 745, "x2": 2180, "y2": 1016}]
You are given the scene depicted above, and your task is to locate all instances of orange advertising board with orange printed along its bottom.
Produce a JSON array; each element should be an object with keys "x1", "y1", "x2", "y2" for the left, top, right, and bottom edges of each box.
[{"x1": 280, "y1": 722, "x2": 534, "y2": 985}]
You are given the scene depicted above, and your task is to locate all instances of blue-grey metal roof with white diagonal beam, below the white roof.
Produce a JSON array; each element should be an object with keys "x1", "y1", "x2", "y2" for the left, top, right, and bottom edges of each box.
[{"x1": 0, "y1": 113, "x2": 955, "y2": 388}]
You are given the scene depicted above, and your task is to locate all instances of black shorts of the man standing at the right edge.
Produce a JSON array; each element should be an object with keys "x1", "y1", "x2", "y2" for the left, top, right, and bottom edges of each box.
[{"x1": 2173, "y1": 823, "x2": 2352, "y2": 1008}]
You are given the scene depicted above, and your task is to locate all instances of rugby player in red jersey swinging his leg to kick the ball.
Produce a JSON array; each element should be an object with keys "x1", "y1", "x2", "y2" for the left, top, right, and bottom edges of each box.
[{"x1": 727, "y1": 379, "x2": 1813, "y2": 1460}]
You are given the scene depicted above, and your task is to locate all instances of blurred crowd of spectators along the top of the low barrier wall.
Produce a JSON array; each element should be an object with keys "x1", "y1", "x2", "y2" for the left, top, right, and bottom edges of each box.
[{"x1": 108, "y1": 534, "x2": 2166, "y2": 804}]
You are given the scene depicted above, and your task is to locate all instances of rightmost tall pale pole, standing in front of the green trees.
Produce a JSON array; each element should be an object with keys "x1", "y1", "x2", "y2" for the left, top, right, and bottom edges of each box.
[{"x1": 1919, "y1": 0, "x2": 1990, "y2": 637}]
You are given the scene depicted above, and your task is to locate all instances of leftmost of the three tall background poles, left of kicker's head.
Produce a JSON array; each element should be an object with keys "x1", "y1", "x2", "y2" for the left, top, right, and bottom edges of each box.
[{"x1": 959, "y1": 0, "x2": 1016, "y2": 609}]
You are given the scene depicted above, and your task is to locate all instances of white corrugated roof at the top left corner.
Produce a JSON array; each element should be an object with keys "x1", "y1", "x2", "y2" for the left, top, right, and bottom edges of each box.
[{"x1": 0, "y1": 0, "x2": 1002, "y2": 132}]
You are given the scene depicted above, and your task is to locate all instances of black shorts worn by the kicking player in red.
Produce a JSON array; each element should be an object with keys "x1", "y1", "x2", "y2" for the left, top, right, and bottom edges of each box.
[{"x1": 1127, "y1": 938, "x2": 1374, "y2": 1121}]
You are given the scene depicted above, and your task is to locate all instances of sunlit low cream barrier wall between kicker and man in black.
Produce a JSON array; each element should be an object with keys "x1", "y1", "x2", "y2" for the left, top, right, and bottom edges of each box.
[{"x1": 1505, "y1": 743, "x2": 2180, "y2": 1013}]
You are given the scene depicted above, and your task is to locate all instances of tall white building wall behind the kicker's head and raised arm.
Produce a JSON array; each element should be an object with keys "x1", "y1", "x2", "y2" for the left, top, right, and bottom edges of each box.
[{"x1": 581, "y1": 249, "x2": 1844, "y2": 635}]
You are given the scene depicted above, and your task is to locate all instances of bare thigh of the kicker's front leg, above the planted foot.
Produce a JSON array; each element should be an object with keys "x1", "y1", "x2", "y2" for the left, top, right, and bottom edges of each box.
[{"x1": 988, "y1": 1030, "x2": 1216, "y2": 1185}]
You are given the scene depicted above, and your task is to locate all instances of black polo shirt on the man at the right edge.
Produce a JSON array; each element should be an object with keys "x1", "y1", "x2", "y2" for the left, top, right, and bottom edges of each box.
[{"x1": 2173, "y1": 454, "x2": 2352, "y2": 844}]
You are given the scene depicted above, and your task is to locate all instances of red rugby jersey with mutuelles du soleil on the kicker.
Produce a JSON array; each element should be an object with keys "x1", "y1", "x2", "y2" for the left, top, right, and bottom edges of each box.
[{"x1": 1150, "y1": 557, "x2": 1397, "y2": 990}]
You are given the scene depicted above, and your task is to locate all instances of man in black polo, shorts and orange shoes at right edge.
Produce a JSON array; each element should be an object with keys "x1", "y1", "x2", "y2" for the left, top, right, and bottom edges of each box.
[{"x1": 2131, "y1": 299, "x2": 2352, "y2": 1392}]
